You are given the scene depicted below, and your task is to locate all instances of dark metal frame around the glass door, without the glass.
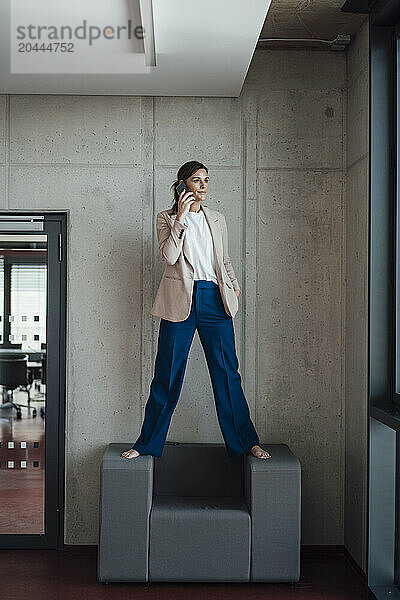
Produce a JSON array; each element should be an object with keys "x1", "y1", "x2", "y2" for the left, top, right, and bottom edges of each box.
[{"x1": 0, "y1": 210, "x2": 69, "y2": 550}]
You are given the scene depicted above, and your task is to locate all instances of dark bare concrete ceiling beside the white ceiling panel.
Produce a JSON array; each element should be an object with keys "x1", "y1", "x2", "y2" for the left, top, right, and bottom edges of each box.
[{"x1": 259, "y1": 0, "x2": 366, "y2": 48}]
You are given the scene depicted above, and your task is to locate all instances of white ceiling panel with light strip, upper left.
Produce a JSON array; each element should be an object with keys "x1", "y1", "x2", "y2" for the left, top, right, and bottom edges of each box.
[{"x1": 0, "y1": 0, "x2": 271, "y2": 97}]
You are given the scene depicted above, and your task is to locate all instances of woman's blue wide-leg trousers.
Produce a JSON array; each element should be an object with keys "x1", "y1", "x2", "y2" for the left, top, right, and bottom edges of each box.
[{"x1": 132, "y1": 280, "x2": 259, "y2": 457}]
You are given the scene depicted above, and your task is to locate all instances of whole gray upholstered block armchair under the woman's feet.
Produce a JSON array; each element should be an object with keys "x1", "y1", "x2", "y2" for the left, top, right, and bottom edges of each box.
[{"x1": 97, "y1": 442, "x2": 301, "y2": 583}]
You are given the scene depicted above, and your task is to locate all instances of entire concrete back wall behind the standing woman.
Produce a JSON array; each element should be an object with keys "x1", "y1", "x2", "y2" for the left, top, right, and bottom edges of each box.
[{"x1": 0, "y1": 44, "x2": 354, "y2": 544}]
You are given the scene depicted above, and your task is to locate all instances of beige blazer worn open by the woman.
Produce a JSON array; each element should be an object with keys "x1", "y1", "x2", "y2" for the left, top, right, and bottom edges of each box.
[{"x1": 151, "y1": 204, "x2": 240, "y2": 322}]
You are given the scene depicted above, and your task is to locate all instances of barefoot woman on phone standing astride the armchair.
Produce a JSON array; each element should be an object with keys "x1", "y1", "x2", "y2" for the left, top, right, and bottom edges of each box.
[{"x1": 121, "y1": 161, "x2": 270, "y2": 458}]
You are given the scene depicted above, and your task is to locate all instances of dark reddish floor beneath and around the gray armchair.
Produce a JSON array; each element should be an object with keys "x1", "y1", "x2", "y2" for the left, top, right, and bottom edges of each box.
[{"x1": 0, "y1": 546, "x2": 367, "y2": 600}]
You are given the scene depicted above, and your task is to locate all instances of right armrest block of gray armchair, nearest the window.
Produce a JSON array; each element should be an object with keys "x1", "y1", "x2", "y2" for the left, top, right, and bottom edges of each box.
[{"x1": 244, "y1": 444, "x2": 301, "y2": 582}]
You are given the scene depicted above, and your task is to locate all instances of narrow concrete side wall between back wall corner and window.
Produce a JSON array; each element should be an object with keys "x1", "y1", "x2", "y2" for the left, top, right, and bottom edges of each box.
[{"x1": 344, "y1": 18, "x2": 369, "y2": 571}]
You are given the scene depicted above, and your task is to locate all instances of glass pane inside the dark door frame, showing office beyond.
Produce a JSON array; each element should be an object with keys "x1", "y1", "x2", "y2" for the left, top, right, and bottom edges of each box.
[{"x1": 0, "y1": 234, "x2": 47, "y2": 535}]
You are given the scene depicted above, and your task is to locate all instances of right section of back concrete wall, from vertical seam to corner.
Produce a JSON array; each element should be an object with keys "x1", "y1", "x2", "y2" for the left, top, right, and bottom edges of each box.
[{"x1": 246, "y1": 50, "x2": 346, "y2": 544}]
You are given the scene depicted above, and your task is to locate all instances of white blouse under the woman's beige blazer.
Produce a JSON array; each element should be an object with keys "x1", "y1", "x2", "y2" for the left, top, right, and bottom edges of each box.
[{"x1": 175, "y1": 208, "x2": 218, "y2": 285}]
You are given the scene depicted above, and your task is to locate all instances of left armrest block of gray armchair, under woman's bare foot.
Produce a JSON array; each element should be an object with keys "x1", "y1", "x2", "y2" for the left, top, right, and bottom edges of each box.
[{"x1": 97, "y1": 444, "x2": 154, "y2": 582}]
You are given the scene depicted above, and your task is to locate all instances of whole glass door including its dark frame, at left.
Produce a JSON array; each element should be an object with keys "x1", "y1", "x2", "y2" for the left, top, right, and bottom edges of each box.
[{"x1": 0, "y1": 214, "x2": 65, "y2": 548}]
